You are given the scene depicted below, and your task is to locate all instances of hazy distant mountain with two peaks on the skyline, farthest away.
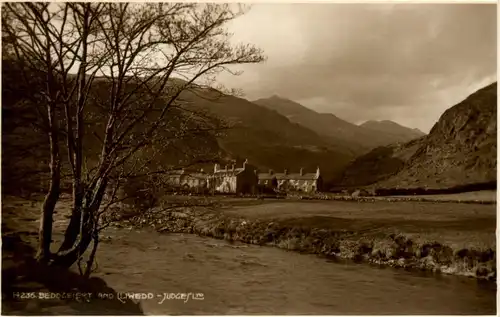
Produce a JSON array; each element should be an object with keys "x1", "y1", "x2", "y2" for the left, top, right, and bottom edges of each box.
[{"x1": 253, "y1": 95, "x2": 423, "y2": 155}]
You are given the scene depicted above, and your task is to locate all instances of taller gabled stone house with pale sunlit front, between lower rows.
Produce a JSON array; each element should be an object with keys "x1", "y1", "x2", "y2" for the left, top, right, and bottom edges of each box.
[{"x1": 208, "y1": 160, "x2": 258, "y2": 194}]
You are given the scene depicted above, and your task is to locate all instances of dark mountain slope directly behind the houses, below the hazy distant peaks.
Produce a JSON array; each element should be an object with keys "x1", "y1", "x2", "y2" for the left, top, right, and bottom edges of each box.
[{"x1": 178, "y1": 90, "x2": 355, "y2": 180}]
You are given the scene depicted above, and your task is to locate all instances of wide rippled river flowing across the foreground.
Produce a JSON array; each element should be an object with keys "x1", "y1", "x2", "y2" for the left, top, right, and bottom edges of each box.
[{"x1": 95, "y1": 228, "x2": 496, "y2": 315}]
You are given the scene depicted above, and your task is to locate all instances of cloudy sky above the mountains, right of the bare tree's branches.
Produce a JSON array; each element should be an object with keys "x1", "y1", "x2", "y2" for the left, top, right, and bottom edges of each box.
[{"x1": 219, "y1": 3, "x2": 497, "y2": 133}]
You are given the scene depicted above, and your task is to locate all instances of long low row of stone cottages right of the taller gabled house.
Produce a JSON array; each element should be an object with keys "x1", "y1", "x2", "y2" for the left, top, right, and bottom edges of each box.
[{"x1": 258, "y1": 167, "x2": 323, "y2": 193}]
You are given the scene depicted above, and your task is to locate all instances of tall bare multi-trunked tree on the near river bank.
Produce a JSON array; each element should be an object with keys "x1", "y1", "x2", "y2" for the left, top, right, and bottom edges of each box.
[{"x1": 2, "y1": 3, "x2": 264, "y2": 267}]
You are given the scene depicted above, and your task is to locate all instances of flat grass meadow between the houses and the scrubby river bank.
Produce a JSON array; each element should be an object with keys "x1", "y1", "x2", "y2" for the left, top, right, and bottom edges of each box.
[{"x1": 226, "y1": 201, "x2": 496, "y2": 249}]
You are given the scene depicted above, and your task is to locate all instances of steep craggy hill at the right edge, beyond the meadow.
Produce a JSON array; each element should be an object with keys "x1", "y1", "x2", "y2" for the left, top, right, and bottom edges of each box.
[{"x1": 342, "y1": 83, "x2": 497, "y2": 189}]
